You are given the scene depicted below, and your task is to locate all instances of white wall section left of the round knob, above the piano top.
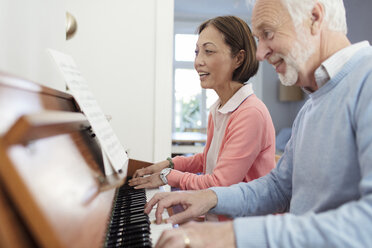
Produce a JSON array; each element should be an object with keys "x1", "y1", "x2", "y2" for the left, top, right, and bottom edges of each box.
[{"x1": 0, "y1": 0, "x2": 65, "y2": 90}]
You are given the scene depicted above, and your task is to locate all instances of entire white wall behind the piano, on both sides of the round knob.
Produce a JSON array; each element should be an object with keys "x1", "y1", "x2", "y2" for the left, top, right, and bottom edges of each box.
[{"x1": 0, "y1": 0, "x2": 174, "y2": 161}]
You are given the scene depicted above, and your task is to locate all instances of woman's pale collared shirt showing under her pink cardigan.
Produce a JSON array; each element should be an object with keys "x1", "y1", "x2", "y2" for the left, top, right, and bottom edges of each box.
[{"x1": 206, "y1": 83, "x2": 254, "y2": 175}]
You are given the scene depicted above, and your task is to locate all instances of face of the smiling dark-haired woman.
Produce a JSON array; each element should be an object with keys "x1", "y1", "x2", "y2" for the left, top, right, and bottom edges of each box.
[{"x1": 194, "y1": 25, "x2": 237, "y2": 91}]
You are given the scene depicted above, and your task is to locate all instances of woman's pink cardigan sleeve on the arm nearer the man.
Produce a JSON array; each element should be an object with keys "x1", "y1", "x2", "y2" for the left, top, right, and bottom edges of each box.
[{"x1": 168, "y1": 107, "x2": 274, "y2": 190}]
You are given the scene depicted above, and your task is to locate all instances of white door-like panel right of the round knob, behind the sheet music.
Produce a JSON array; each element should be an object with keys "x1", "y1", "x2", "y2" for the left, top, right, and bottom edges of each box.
[{"x1": 66, "y1": 0, "x2": 173, "y2": 161}]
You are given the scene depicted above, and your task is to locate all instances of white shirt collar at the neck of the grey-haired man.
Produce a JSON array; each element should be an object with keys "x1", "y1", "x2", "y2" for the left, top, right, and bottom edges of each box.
[{"x1": 314, "y1": 41, "x2": 369, "y2": 88}]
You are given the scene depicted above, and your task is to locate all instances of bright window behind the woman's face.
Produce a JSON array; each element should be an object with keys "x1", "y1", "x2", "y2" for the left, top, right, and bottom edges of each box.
[{"x1": 173, "y1": 34, "x2": 218, "y2": 132}]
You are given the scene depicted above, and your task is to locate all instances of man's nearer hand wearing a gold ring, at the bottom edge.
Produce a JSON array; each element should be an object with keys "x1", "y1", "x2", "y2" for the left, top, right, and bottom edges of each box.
[{"x1": 155, "y1": 221, "x2": 236, "y2": 248}]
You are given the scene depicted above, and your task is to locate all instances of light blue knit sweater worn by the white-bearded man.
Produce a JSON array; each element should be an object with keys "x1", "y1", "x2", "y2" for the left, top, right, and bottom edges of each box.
[{"x1": 211, "y1": 47, "x2": 372, "y2": 248}]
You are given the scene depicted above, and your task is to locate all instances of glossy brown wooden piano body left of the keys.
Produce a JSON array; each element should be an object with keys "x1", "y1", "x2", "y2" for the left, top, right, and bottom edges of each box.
[{"x1": 0, "y1": 73, "x2": 169, "y2": 248}]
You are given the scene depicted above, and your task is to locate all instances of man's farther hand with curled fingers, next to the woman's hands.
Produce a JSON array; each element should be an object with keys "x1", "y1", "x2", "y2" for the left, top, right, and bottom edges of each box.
[{"x1": 145, "y1": 189, "x2": 217, "y2": 224}]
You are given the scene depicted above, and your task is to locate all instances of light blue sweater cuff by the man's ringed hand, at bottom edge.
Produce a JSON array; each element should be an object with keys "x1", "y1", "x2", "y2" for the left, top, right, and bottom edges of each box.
[{"x1": 233, "y1": 216, "x2": 269, "y2": 248}]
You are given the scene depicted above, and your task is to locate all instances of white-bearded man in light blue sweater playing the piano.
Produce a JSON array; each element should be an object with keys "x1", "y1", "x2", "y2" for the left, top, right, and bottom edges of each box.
[{"x1": 145, "y1": 0, "x2": 372, "y2": 247}]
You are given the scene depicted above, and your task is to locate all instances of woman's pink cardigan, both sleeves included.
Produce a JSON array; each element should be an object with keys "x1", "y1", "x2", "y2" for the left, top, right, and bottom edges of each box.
[{"x1": 167, "y1": 94, "x2": 275, "y2": 190}]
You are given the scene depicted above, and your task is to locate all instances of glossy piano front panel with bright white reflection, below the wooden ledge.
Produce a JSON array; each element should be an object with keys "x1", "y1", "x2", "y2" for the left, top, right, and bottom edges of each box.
[{"x1": 0, "y1": 133, "x2": 115, "y2": 247}]
